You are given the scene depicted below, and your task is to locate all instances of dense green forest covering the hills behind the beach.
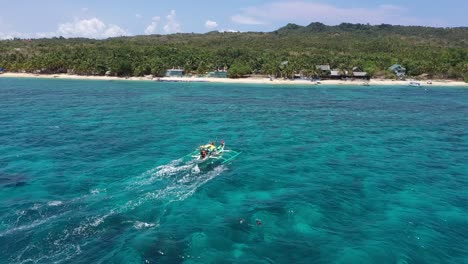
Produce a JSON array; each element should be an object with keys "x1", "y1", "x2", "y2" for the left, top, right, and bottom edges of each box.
[{"x1": 0, "y1": 23, "x2": 468, "y2": 81}]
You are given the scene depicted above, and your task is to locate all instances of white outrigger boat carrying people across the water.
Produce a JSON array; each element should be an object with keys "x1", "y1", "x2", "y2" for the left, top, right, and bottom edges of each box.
[{"x1": 186, "y1": 141, "x2": 241, "y2": 164}]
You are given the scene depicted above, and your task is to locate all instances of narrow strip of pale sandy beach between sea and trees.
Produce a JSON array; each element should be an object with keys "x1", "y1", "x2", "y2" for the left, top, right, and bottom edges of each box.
[{"x1": 0, "y1": 72, "x2": 468, "y2": 87}]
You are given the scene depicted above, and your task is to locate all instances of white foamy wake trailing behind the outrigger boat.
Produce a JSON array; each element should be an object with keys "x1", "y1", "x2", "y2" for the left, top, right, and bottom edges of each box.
[{"x1": 0, "y1": 159, "x2": 225, "y2": 263}]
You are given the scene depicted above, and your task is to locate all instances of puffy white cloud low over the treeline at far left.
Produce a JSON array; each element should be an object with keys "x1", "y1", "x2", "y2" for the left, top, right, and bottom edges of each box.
[{"x1": 56, "y1": 18, "x2": 128, "y2": 39}]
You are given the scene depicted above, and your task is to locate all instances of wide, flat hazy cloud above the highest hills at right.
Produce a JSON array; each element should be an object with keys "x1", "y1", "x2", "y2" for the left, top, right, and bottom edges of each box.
[{"x1": 231, "y1": 1, "x2": 422, "y2": 25}]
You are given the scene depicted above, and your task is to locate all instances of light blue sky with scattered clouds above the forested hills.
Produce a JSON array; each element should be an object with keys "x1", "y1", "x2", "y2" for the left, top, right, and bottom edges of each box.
[{"x1": 0, "y1": 0, "x2": 468, "y2": 39}]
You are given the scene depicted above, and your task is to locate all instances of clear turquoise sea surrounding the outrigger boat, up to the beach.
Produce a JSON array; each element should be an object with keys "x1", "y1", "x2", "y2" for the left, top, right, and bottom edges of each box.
[{"x1": 0, "y1": 78, "x2": 468, "y2": 264}]
